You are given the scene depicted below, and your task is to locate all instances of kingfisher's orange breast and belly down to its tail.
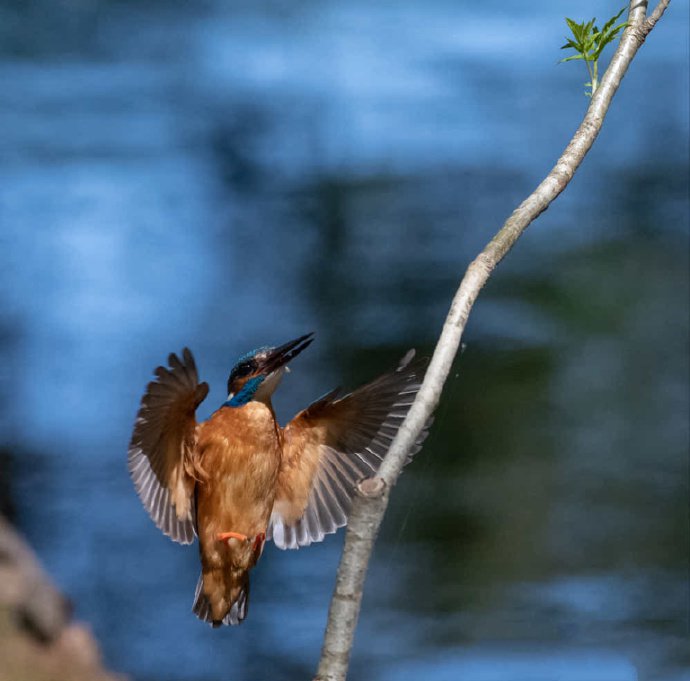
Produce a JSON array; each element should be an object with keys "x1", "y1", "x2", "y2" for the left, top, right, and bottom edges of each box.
[{"x1": 195, "y1": 402, "x2": 281, "y2": 623}]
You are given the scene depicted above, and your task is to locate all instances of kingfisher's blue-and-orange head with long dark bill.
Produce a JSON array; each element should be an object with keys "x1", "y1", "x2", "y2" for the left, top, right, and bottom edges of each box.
[{"x1": 225, "y1": 333, "x2": 314, "y2": 407}]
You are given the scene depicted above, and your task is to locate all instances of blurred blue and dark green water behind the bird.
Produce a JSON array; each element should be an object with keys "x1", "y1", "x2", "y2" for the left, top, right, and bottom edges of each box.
[{"x1": 0, "y1": 0, "x2": 690, "y2": 681}]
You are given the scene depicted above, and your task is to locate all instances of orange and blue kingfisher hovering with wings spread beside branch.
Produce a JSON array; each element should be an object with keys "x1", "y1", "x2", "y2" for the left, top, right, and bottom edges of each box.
[{"x1": 128, "y1": 333, "x2": 426, "y2": 627}]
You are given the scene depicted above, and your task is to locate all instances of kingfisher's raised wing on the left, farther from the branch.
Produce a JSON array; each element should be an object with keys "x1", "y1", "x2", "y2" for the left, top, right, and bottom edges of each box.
[{"x1": 127, "y1": 348, "x2": 208, "y2": 544}]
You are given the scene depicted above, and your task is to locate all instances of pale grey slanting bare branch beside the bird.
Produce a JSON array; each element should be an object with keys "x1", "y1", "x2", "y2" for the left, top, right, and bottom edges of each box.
[{"x1": 314, "y1": 0, "x2": 670, "y2": 681}]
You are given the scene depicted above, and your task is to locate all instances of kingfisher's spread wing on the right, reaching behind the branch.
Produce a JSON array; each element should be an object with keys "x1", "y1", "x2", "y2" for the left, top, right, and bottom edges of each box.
[{"x1": 267, "y1": 350, "x2": 428, "y2": 549}]
